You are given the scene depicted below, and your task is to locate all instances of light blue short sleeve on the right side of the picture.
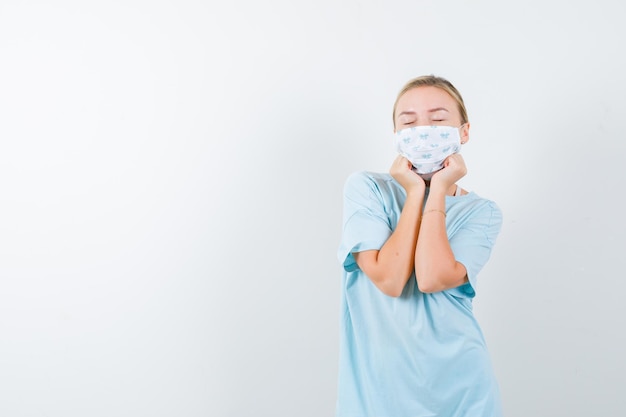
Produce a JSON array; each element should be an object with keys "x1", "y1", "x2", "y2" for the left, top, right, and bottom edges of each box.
[{"x1": 449, "y1": 201, "x2": 502, "y2": 298}]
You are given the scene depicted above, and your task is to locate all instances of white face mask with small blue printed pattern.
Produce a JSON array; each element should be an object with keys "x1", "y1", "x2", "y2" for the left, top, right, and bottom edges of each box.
[{"x1": 395, "y1": 126, "x2": 461, "y2": 174}]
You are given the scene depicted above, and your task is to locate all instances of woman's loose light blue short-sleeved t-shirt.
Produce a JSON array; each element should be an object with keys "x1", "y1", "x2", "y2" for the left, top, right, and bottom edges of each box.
[{"x1": 336, "y1": 172, "x2": 502, "y2": 417}]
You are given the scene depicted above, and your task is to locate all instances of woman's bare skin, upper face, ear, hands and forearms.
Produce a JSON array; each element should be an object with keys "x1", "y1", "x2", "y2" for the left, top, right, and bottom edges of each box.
[{"x1": 353, "y1": 86, "x2": 469, "y2": 297}]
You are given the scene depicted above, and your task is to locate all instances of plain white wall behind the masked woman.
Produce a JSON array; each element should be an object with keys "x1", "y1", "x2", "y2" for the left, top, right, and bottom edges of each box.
[{"x1": 0, "y1": 0, "x2": 626, "y2": 417}]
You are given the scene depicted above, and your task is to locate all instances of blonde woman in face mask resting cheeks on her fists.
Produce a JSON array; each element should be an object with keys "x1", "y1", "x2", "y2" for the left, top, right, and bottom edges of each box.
[{"x1": 336, "y1": 76, "x2": 502, "y2": 417}]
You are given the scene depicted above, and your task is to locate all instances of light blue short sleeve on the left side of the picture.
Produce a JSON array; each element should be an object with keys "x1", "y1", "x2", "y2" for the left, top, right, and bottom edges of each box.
[{"x1": 337, "y1": 172, "x2": 392, "y2": 272}]
